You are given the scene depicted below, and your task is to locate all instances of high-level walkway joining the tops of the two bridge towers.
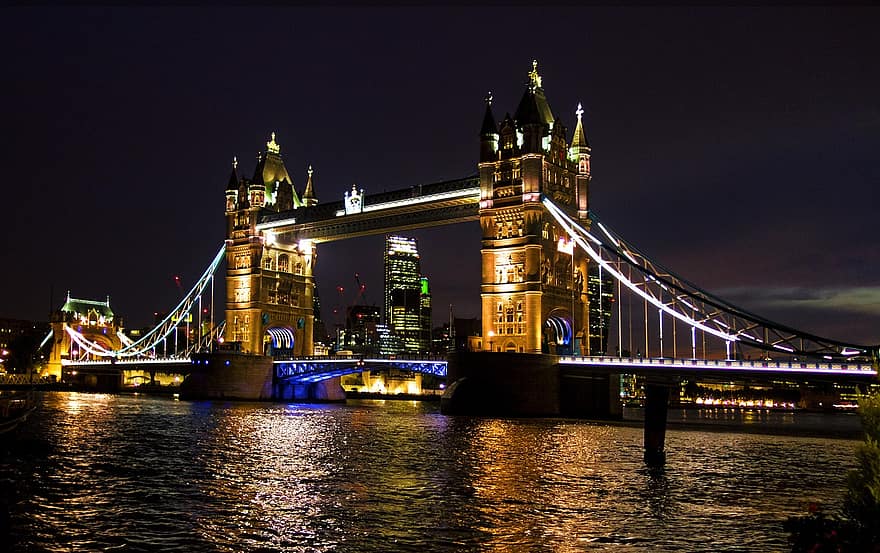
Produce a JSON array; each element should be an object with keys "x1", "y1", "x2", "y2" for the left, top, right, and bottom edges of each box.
[{"x1": 257, "y1": 176, "x2": 480, "y2": 243}]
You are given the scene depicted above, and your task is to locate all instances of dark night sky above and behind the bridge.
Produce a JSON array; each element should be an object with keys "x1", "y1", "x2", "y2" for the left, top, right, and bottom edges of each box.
[{"x1": 0, "y1": 6, "x2": 880, "y2": 344}]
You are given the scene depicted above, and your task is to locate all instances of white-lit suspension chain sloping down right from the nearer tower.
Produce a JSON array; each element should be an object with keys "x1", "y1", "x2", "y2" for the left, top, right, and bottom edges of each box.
[{"x1": 542, "y1": 198, "x2": 877, "y2": 360}]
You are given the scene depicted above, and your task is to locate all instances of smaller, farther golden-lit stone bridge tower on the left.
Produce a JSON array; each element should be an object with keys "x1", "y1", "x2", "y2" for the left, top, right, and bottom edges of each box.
[{"x1": 225, "y1": 133, "x2": 317, "y2": 355}]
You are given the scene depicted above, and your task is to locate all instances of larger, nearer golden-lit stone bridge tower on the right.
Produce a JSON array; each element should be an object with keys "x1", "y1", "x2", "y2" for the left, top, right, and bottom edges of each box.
[{"x1": 479, "y1": 62, "x2": 590, "y2": 354}]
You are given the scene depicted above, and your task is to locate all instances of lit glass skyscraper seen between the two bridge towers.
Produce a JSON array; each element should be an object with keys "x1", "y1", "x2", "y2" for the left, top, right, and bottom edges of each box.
[{"x1": 383, "y1": 235, "x2": 430, "y2": 353}]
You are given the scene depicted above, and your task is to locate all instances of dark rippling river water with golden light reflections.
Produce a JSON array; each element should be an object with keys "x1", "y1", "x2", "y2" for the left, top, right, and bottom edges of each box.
[{"x1": 0, "y1": 393, "x2": 858, "y2": 553}]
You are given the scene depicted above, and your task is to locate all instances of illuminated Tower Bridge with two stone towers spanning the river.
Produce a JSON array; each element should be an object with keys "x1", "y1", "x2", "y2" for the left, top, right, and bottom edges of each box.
[{"x1": 43, "y1": 63, "x2": 880, "y2": 462}]
